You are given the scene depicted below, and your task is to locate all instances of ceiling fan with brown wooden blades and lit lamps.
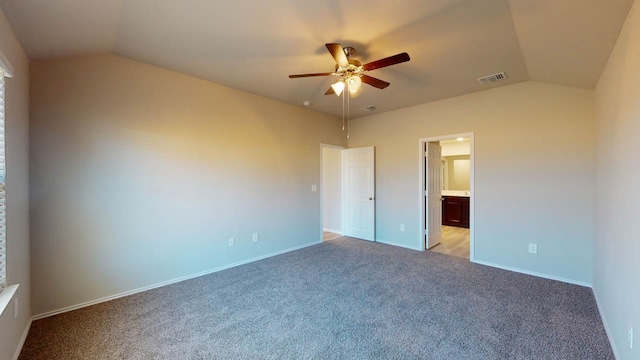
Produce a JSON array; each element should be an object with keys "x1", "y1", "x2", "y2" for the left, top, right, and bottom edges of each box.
[{"x1": 289, "y1": 43, "x2": 410, "y2": 97}]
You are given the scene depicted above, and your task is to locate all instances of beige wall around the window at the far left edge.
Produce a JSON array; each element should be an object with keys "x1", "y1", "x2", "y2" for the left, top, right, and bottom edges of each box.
[{"x1": 0, "y1": 5, "x2": 31, "y2": 359}]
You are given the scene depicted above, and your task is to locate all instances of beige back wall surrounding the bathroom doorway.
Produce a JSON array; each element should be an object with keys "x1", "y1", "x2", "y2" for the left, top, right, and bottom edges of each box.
[{"x1": 349, "y1": 82, "x2": 594, "y2": 284}]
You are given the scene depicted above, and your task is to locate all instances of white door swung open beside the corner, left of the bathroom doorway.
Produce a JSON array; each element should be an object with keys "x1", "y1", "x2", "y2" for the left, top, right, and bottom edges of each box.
[{"x1": 342, "y1": 146, "x2": 376, "y2": 241}]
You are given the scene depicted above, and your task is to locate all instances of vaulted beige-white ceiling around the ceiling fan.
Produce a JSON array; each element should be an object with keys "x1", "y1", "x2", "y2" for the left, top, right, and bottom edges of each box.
[{"x1": 0, "y1": 0, "x2": 633, "y2": 118}]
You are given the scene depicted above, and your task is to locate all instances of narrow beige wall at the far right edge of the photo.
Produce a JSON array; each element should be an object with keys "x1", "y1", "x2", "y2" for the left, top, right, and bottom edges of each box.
[{"x1": 593, "y1": 1, "x2": 640, "y2": 360}]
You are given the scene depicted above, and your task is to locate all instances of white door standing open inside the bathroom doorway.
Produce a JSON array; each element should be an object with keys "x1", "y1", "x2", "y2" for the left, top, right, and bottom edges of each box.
[{"x1": 424, "y1": 143, "x2": 442, "y2": 249}]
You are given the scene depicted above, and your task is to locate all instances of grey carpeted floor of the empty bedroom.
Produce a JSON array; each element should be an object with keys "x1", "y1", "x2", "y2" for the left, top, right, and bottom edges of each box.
[{"x1": 20, "y1": 238, "x2": 614, "y2": 360}]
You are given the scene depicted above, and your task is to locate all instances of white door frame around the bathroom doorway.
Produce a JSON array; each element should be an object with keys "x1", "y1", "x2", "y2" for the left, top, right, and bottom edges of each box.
[{"x1": 417, "y1": 132, "x2": 475, "y2": 262}]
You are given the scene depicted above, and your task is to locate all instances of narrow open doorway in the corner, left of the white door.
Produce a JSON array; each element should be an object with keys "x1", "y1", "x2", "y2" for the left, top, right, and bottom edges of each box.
[{"x1": 320, "y1": 144, "x2": 344, "y2": 241}]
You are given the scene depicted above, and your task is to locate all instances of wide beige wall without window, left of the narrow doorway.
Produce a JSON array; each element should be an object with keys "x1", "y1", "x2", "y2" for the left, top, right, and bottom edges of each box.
[{"x1": 31, "y1": 55, "x2": 345, "y2": 314}]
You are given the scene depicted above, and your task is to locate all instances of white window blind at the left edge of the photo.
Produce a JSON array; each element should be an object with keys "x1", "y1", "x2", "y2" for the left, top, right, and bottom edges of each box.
[{"x1": 0, "y1": 67, "x2": 7, "y2": 290}]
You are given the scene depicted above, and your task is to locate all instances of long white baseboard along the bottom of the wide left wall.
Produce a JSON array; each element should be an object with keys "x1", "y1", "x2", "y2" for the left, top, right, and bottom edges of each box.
[{"x1": 32, "y1": 240, "x2": 322, "y2": 320}]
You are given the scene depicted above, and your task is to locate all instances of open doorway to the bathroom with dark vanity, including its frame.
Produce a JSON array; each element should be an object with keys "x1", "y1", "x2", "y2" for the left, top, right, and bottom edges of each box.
[{"x1": 420, "y1": 133, "x2": 475, "y2": 261}]
